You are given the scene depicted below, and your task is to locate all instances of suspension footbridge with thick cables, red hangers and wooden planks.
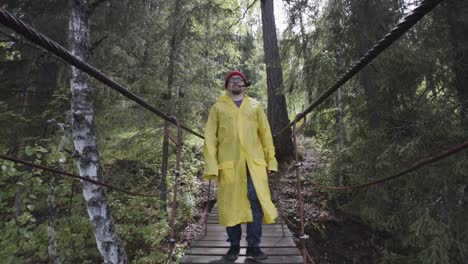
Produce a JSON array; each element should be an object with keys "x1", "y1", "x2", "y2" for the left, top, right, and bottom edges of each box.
[{"x1": 0, "y1": 0, "x2": 468, "y2": 263}]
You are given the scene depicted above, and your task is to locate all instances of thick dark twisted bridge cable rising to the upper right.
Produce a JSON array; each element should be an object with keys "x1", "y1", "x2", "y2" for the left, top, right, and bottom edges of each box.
[{"x1": 274, "y1": 0, "x2": 443, "y2": 137}]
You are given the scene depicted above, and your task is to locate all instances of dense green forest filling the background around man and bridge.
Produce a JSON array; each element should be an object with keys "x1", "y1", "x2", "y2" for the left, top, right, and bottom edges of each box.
[{"x1": 0, "y1": 0, "x2": 468, "y2": 263}]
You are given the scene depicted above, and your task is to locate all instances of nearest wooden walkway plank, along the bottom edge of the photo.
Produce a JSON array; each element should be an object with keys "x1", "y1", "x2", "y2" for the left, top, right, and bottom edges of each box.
[{"x1": 180, "y1": 255, "x2": 303, "y2": 264}]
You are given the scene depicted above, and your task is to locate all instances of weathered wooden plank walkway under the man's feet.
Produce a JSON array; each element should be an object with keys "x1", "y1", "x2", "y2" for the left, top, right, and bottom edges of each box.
[{"x1": 180, "y1": 205, "x2": 303, "y2": 264}]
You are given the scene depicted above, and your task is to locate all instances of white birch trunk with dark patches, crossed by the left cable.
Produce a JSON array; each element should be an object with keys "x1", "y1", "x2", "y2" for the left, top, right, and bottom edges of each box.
[{"x1": 69, "y1": 0, "x2": 128, "y2": 263}]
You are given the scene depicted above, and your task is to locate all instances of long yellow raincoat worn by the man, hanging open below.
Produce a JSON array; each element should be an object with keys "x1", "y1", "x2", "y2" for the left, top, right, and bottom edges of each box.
[{"x1": 203, "y1": 95, "x2": 278, "y2": 226}]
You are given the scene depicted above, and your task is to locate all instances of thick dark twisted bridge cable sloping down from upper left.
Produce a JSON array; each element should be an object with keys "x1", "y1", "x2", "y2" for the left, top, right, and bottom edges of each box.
[{"x1": 0, "y1": 8, "x2": 203, "y2": 138}]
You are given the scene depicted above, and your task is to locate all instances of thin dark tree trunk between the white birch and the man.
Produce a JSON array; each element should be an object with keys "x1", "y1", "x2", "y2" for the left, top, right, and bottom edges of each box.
[{"x1": 160, "y1": 0, "x2": 181, "y2": 210}]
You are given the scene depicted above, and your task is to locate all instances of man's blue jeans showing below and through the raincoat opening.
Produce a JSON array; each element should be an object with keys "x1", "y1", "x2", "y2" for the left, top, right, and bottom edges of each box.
[{"x1": 226, "y1": 168, "x2": 263, "y2": 247}]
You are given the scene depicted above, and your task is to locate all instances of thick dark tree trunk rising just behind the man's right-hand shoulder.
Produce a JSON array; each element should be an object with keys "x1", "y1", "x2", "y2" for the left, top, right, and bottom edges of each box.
[{"x1": 261, "y1": 0, "x2": 293, "y2": 161}]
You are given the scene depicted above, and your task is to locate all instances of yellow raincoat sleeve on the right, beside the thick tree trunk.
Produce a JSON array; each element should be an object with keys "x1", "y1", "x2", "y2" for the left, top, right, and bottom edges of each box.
[{"x1": 257, "y1": 107, "x2": 278, "y2": 171}]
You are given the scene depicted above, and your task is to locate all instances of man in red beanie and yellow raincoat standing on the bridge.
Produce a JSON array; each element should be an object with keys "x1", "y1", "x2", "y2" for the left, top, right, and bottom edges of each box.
[{"x1": 203, "y1": 71, "x2": 278, "y2": 261}]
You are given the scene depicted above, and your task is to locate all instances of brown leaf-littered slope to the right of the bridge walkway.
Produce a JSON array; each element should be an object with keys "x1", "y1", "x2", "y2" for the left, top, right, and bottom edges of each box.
[{"x1": 270, "y1": 138, "x2": 382, "y2": 264}]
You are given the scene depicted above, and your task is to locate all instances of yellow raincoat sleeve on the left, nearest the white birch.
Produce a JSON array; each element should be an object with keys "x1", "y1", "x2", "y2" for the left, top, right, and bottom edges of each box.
[{"x1": 203, "y1": 106, "x2": 218, "y2": 180}]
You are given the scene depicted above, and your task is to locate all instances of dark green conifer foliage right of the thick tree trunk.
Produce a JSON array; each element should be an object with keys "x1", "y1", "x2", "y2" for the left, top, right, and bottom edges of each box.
[{"x1": 282, "y1": 0, "x2": 468, "y2": 263}]
